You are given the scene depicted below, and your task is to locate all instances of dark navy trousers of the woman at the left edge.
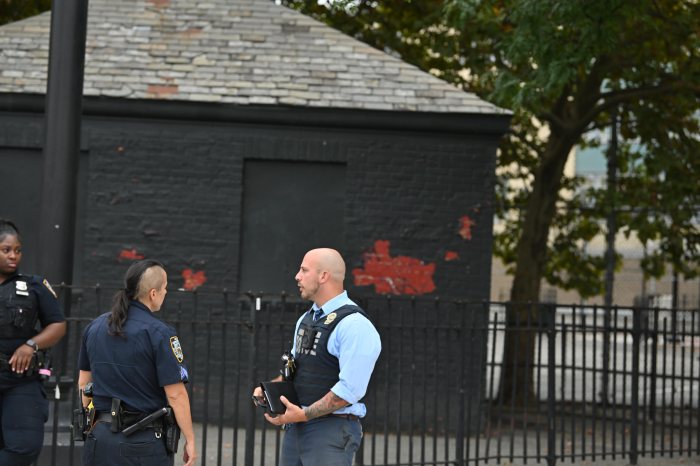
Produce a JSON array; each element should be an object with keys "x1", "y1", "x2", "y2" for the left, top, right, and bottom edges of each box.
[{"x1": 0, "y1": 380, "x2": 49, "y2": 466}]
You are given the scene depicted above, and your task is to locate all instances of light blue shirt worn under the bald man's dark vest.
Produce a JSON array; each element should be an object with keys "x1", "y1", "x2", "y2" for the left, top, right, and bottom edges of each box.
[{"x1": 292, "y1": 291, "x2": 382, "y2": 417}]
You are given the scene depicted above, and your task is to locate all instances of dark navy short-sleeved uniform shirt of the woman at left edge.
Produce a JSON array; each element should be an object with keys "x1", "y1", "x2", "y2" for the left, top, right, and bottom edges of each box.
[{"x1": 0, "y1": 274, "x2": 66, "y2": 356}]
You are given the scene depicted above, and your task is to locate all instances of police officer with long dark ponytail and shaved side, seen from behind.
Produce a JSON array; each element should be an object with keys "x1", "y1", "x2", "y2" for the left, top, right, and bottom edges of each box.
[{"x1": 78, "y1": 260, "x2": 196, "y2": 466}]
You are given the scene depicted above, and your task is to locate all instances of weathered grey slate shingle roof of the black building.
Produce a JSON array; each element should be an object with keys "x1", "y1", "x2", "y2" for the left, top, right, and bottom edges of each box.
[{"x1": 0, "y1": 0, "x2": 506, "y2": 114}]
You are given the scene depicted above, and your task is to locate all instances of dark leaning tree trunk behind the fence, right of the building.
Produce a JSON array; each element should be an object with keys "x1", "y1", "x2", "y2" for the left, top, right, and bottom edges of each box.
[{"x1": 499, "y1": 126, "x2": 577, "y2": 407}]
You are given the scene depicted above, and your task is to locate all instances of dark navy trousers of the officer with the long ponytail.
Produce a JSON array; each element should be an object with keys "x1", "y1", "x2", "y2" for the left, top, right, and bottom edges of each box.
[{"x1": 83, "y1": 422, "x2": 175, "y2": 466}]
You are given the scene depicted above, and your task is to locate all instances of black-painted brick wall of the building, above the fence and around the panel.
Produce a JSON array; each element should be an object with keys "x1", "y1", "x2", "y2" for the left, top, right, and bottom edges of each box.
[{"x1": 0, "y1": 110, "x2": 496, "y2": 300}]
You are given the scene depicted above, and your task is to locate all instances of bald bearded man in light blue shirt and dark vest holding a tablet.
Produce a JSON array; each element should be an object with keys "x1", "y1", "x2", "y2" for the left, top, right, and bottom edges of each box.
[{"x1": 253, "y1": 248, "x2": 381, "y2": 466}]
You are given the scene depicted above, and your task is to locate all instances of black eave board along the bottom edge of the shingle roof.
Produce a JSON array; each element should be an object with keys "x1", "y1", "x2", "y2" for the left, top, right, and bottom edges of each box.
[{"x1": 0, "y1": 93, "x2": 511, "y2": 138}]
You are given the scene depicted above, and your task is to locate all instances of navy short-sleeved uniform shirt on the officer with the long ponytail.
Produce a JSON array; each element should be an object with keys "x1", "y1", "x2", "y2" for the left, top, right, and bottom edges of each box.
[{"x1": 78, "y1": 301, "x2": 188, "y2": 413}]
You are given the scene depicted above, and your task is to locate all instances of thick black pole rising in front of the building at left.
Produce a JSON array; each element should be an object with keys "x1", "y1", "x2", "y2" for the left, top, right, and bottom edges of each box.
[{"x1": 39, "y1": 0, "x2": 88, "y2": 292}]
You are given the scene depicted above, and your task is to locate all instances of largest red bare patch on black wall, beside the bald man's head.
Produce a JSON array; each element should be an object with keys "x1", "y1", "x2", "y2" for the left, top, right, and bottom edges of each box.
[{"x1": 352, "y1": 240, "x2": 435, "y2": 295}]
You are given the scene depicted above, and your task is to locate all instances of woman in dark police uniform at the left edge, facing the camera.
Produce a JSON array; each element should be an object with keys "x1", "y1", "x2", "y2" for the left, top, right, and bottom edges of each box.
[{"x1": 0, "y1": 219, "x2": 66, "y2": 466}]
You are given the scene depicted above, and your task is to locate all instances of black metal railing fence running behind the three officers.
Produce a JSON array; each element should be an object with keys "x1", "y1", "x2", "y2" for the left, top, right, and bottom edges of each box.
[{"x1": 38, "y1": 287, "x2": 700, "y2": 466}]
